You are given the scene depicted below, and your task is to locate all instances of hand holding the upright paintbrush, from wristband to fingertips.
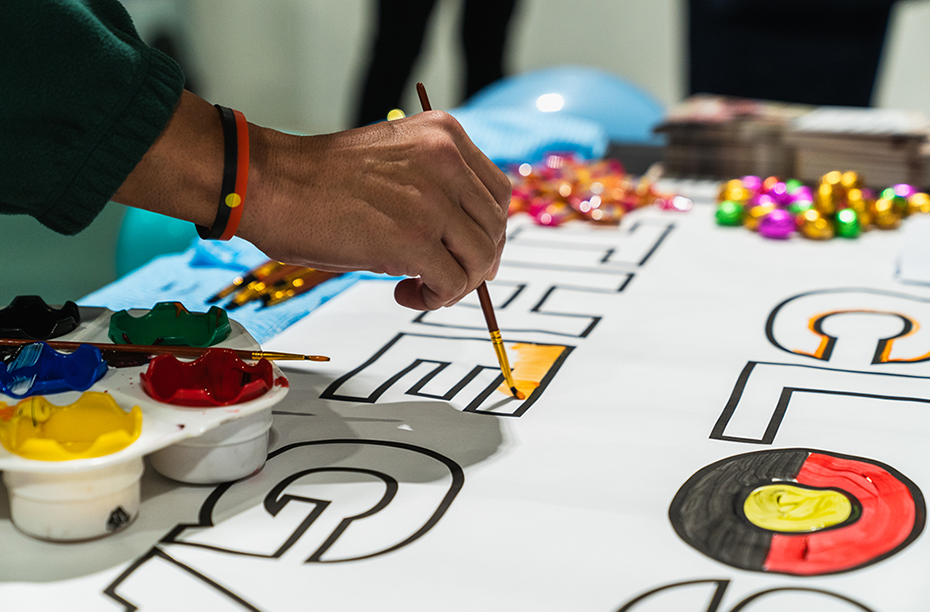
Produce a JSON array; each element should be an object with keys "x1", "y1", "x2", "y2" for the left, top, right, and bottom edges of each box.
[{"x1": 238, "y1": 111, "x2": 511, "y2": 310}]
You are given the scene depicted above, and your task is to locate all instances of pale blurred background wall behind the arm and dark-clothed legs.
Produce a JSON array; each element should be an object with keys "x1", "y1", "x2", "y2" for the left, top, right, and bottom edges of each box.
[{"x1": 0, "y1": 0, "x2": 930, "y2": 306}]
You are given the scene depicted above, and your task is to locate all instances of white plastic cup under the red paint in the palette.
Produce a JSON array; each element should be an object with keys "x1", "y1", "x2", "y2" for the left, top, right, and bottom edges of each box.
[{"x1": 149, "y1": 406, "x2": 272, "y2": 484}]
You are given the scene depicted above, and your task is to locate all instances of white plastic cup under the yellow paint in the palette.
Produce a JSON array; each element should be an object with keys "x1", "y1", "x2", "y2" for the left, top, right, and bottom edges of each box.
[{"x1": 3, "y1": 458, "x2": 143, "y2": 542}]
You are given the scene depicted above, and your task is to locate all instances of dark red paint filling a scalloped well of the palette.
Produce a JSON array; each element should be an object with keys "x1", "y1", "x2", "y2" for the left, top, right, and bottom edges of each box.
[{"x1": 140, "y1": 348, "x2": 276, "y2": 406}]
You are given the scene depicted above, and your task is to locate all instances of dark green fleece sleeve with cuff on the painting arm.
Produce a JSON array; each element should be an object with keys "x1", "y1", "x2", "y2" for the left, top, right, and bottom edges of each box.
[{"x1": 0, "y1": 0, "x2": 184, "y2": 234}]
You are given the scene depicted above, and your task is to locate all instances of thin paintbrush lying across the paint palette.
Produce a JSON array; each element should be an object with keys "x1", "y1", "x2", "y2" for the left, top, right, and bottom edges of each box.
[{"x1": 0, "y1": 338, "x2": 329, "y2": 366}]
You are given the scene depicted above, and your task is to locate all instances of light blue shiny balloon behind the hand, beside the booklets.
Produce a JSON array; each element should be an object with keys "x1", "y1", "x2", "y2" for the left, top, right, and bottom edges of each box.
[{"x1": 462, "y1": 66, "x2": 665, "y2": 144}]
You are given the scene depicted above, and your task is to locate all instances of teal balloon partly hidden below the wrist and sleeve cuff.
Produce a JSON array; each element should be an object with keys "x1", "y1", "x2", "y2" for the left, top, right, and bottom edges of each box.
[{"x1": 116, "y1": 208, "x2": 198, "y2": 276}]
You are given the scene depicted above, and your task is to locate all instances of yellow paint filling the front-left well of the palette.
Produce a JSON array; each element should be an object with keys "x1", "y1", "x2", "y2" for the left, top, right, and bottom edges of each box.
[{"x1": 0, "y1": 391, "x2": 142, "y2": 461}]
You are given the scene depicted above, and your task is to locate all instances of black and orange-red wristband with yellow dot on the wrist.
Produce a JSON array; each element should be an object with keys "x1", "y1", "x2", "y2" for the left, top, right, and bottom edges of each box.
[{"x1": 197, "y1": 104, "x2": 249, "y2": 240}]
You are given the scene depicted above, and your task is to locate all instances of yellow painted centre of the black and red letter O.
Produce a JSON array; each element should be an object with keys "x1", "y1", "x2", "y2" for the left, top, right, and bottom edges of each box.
[{"x1": 743, "y1": 483, "x2": 852, "y2": 533}]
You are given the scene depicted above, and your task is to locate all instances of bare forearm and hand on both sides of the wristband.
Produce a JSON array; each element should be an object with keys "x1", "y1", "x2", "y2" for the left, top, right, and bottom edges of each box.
[{"x1": 114, "y1": 92, "x2": 510, "y2": 309}]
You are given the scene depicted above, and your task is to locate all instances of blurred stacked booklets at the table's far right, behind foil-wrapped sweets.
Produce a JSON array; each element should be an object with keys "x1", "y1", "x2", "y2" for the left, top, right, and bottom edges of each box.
[{"x1": 656, "y1": 95, "x2": 930, "y2": 187}]
